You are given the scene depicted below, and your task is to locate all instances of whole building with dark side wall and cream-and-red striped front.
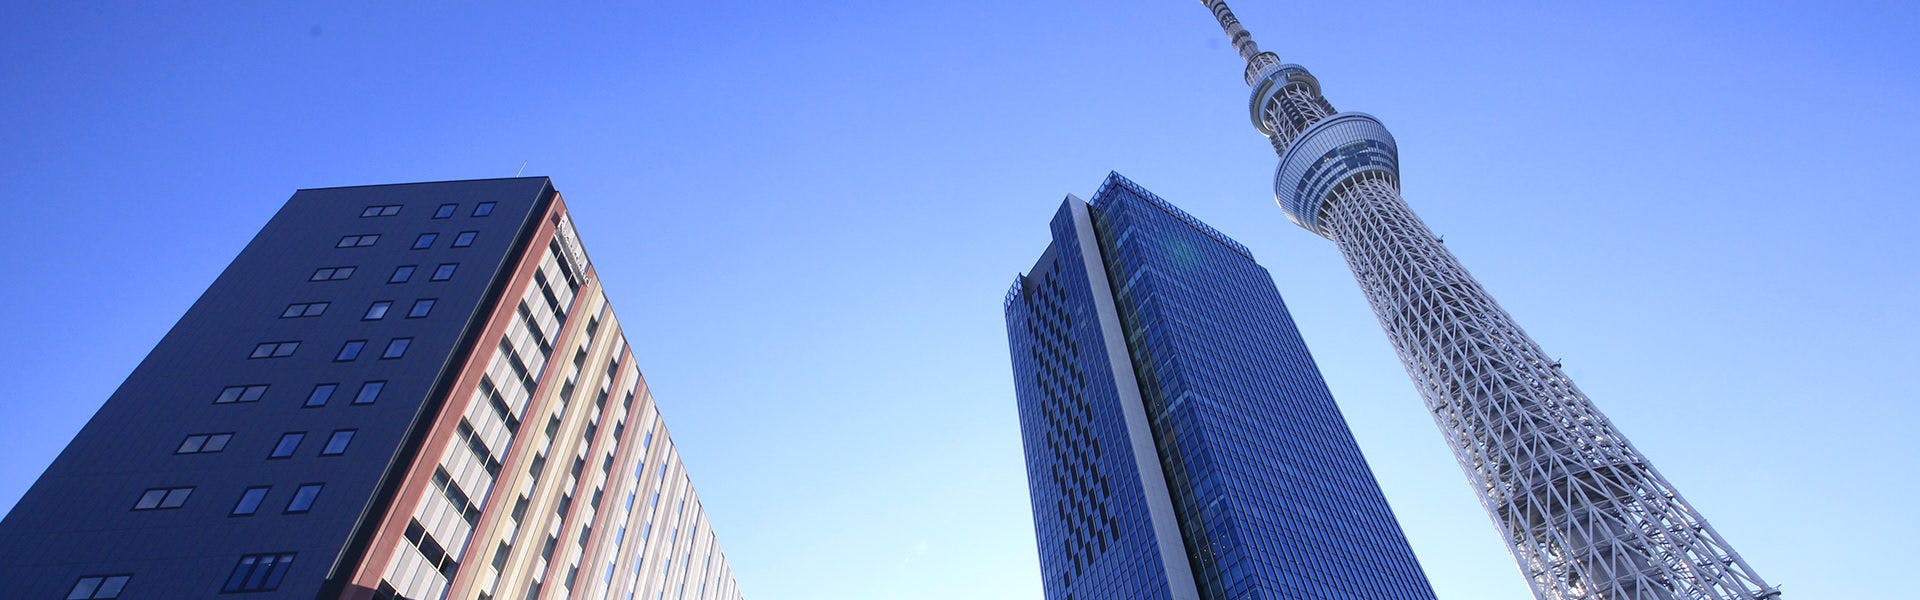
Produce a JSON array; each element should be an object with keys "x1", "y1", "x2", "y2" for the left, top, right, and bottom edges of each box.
[{"x1": 0, "y1": 177, "x2": 741, "y2": 600}]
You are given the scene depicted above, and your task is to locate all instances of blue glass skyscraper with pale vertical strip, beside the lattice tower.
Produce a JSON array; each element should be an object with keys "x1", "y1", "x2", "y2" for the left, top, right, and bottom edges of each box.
[{"x1": 1006, "y1": 173, "x2": 1434, "y2": 600}]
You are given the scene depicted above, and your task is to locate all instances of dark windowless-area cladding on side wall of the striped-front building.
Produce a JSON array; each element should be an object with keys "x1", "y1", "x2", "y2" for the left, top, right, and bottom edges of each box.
[{"x1": 0, "y1": 177, "x2": 551, "y2": 598}]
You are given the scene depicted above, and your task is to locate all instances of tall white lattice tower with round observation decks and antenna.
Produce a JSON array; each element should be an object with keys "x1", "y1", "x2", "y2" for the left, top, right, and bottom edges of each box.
[{"x1": 1202, "y1": 0, "x2": 1780, "y2": 600}]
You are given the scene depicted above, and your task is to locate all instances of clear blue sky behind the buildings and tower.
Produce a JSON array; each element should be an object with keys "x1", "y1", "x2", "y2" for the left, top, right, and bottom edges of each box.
[{"x1": 0, "y1": 0, "x2": 1920, "y2": 600}]
